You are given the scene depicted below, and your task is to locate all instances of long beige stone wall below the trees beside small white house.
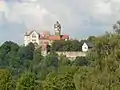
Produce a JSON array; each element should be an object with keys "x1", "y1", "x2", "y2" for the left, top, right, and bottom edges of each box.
[{"x1": 56, "y1": 52, "x2": 86, "y2": 60}]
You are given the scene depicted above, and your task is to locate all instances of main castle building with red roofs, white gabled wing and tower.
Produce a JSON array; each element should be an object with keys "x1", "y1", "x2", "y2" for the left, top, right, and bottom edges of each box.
[{"x1": 24, "y1": 21, "x2": 69, "y2": 54}]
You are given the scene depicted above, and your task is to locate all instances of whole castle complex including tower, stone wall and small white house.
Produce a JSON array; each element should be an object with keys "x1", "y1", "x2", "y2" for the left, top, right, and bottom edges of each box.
[{"x1": 24, "y1": 21, "x2": 91, "y2": 57}]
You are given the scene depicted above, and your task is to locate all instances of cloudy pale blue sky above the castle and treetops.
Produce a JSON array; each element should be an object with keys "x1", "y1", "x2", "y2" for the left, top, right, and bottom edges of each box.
[{"x1": 0, "y1": 0, "x2": 120, "y2": 43}]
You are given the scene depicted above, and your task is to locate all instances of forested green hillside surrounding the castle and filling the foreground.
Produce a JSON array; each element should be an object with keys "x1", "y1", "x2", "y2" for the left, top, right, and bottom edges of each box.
[{"x1": 0, "y1": 23, "x2": 120, "y2": 90}]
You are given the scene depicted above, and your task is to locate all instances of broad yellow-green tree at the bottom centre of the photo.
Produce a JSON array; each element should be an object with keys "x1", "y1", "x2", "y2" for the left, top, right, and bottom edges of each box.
[{"x1": 43, "y1": 67, "x2": 76, "y2": 90}]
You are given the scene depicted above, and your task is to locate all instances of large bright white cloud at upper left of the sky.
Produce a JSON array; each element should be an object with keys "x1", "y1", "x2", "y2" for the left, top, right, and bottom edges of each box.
[{"x1": 3, "y1": 3, "x2": 51, "y2": 28}]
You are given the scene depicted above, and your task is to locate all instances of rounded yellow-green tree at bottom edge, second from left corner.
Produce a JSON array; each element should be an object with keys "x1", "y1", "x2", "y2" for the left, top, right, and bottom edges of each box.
[{"x1": 16, "y1": 72, "x2": 35, "y2": 90}]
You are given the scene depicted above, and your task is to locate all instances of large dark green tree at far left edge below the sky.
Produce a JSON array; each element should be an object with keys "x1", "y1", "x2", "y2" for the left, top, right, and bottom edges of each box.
[{"x1": 0, "y1": 41, "x2": 21, "y2": 75}]
